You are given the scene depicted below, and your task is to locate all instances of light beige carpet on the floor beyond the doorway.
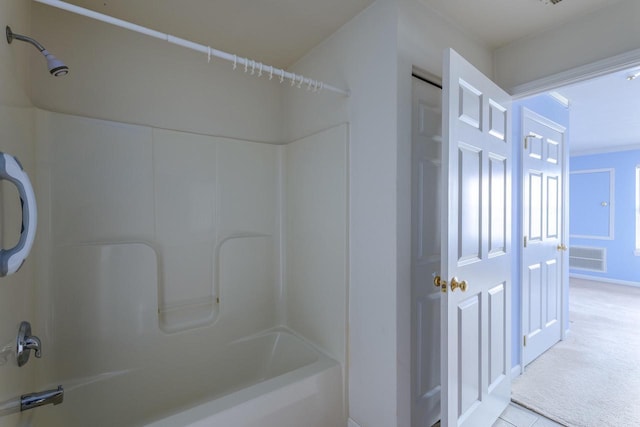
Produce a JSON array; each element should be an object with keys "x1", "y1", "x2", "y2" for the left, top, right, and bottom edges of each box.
[{"x1": 512, "y1": 279, "x2": 640, "y2": 427}]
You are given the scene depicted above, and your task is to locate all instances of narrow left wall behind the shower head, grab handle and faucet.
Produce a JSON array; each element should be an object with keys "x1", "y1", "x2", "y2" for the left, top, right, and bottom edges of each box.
[{"x1": 0, "y1": 0, "x2": 37, "y2": 427}]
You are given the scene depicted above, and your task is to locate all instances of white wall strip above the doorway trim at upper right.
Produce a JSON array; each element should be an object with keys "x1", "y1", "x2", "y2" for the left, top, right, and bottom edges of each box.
[{"x1": 494, "y1": 0, "x2": 640, "y2": 90}]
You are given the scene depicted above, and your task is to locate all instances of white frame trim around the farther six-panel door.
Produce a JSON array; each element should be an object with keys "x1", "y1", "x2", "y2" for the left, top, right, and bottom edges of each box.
[{"x1": 516, "y1": 106, "x2": 569, "y2": 374}]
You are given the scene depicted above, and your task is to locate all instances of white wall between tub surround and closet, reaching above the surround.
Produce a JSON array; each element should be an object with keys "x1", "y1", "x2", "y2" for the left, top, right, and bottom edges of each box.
[{"x1": 285, "y1": 1, "x2": 397, "y2": 427}]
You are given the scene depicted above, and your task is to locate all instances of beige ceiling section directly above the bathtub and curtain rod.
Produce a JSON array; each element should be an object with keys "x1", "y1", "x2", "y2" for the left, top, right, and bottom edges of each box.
[{"x1": 63, "y1": 0, "x2": 373, "y2": 68}]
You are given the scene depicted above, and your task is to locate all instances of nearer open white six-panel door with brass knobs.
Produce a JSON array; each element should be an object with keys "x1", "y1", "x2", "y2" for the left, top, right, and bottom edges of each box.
[{"x1": 442, "y1": 50, "x2": 513, "y2": 426}]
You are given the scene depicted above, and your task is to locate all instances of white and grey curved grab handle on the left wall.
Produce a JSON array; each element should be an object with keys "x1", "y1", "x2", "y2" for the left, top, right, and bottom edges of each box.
[{"x1": 0, "y1": 153, "x2": 38, "y2": 277}]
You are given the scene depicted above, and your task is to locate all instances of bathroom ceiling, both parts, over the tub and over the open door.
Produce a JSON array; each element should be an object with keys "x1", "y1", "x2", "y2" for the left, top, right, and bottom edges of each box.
[{"x1": 63, "y1": 0, "x2": 621, "y2": 68}]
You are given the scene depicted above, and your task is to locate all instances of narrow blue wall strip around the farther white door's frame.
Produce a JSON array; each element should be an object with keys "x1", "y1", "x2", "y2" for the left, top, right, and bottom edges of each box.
[{"x1": 511, "y1": 94, "x2": 570, "y2": 372}]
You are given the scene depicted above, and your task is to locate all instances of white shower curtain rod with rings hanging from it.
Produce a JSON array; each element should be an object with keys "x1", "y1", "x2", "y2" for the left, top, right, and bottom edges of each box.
[{"x1": 34, "y1": 0, "x2": 350, "y2": 97}]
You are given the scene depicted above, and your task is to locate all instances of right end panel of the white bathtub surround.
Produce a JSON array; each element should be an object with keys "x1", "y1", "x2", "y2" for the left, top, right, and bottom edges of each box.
[{"x1": 283, "y1": 124, "x2": 349, "y2": 425}]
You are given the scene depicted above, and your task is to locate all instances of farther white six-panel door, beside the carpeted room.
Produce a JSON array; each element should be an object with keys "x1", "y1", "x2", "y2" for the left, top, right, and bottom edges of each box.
[{"x1": 522, "y1": 109, "x2": 566, "y2": 365}]
